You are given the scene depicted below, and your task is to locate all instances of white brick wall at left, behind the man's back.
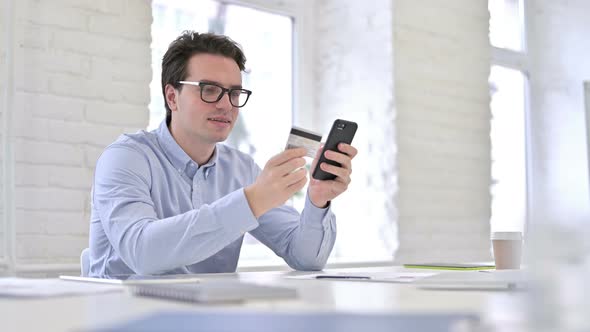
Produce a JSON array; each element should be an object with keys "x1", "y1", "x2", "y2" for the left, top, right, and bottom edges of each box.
[{"x1": 0, "y1": 0, "x2": 152, "y2": 270}]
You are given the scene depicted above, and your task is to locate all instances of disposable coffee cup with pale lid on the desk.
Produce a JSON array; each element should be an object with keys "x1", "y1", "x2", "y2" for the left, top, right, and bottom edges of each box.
[{"x1": 491, "y1": 232, "x2": 522, "y2": 270}]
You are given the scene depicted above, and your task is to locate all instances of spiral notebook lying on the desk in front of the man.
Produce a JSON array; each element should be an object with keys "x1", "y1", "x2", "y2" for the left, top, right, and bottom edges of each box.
[{"x1": 131, "y1": 280, "x2": 297, "y2": 302}]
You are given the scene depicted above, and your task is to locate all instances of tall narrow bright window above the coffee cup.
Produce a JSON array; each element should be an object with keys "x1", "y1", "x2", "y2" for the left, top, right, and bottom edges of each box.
[{"x1": 488, "y1": 0, "x2": 528, "y2": 231}]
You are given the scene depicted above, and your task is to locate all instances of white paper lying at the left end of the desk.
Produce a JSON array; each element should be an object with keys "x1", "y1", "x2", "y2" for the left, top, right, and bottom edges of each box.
[{"x1": 0, "y1": 278, "x2": 125, "y2": 298}]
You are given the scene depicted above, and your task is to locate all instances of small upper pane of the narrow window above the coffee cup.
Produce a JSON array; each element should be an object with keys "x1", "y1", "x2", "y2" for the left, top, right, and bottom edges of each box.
[{"x1": 488, "y1": 0, "x2": 524, "y2": 51}]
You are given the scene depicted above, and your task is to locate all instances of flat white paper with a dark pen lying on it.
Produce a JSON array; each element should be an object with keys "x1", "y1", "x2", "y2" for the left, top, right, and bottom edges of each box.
[{"x1": 285, "y1": 272, "x2": 437, "y2": 284}]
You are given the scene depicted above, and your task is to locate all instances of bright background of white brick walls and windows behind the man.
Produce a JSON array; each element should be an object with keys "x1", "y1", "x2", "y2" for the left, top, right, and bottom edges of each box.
[{"x1": 0, "y1": 0, "x2": 590, "y2": 275}]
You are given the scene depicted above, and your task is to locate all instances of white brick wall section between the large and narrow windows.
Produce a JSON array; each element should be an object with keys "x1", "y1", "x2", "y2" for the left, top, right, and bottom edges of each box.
[{"x1": 393, "y1": 0, "x2": 491, "y2": 262}]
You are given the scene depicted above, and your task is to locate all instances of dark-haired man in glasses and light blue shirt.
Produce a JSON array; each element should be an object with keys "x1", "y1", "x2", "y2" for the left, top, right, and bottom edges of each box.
[{"x1": 89, "y1": 31, "x2": 357, "y2": 276}]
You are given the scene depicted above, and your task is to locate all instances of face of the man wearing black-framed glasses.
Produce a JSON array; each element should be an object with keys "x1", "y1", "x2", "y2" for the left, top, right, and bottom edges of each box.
[{"x1": 166, "y1": 53, "x2": 242, "y2": 144}]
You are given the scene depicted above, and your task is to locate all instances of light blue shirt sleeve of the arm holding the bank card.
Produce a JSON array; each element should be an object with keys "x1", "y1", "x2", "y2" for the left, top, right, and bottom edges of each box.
[{"x1": 93, "y1": 146, "x2": 258, "y2": 274}]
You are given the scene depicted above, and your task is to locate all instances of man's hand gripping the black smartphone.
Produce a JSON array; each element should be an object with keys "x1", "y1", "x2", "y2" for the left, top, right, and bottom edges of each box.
[{"x1": 308, "y1": 143, "x2": 358, "y2": 208}]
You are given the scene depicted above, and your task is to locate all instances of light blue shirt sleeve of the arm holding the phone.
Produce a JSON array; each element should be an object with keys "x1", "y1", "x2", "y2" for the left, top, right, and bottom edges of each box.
[{"x1": 250, "y1": 165, "x2": 336, "y2": 271}]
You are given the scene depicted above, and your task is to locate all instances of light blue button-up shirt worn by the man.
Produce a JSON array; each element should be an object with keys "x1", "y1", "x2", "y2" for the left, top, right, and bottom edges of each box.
[{"x1": 89, "y1": 121, "x2": 336, "y2": 276}]
